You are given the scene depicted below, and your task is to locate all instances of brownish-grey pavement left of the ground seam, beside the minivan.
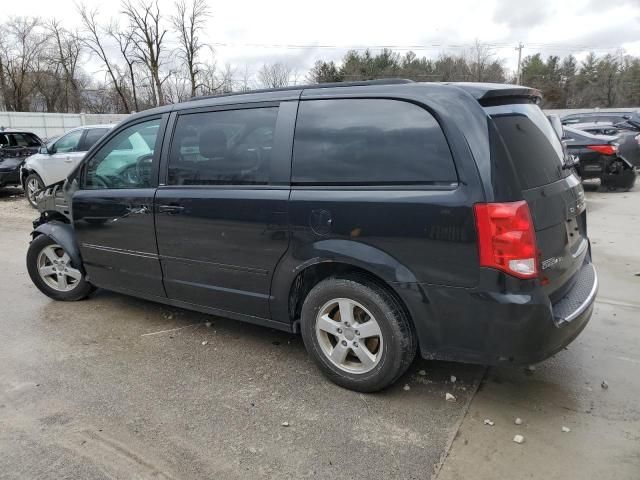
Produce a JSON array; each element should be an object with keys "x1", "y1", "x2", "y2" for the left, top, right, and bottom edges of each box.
[{"x1": 0, "y1": 190, "x2": 484, "y2": 479}]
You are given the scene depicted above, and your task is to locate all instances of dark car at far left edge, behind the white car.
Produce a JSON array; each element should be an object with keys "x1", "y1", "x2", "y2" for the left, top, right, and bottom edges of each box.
[{"x1": 0, "y1": 128, "x2": 42, "y2": 188}]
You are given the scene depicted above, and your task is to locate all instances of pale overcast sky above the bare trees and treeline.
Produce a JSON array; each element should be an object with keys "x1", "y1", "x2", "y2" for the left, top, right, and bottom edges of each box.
[{"x1": 2, "y1": 0, "x2": 640, "y2": 78}]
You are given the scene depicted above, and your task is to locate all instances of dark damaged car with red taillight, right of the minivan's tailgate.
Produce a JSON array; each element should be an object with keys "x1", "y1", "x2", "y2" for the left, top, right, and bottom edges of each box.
[{"x1": 563, "y1": 127, "x2": 637, "y2": 190}]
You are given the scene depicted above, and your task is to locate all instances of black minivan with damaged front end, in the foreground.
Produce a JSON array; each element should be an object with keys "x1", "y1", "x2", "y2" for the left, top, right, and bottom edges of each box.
[{"x1": 27, "y1": 80, "x2": 598, "y2": 391}]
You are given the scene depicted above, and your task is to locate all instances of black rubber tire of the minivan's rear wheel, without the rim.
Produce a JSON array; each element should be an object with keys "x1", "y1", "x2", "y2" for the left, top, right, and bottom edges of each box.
[{"x1": 301, "y1": 275, "x2": 417, "y2": 392}]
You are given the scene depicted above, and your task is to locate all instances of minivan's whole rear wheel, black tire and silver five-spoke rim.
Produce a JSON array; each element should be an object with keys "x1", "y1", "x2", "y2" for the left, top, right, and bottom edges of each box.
[{"x1": 301, "y1": 276, "x2": 417, "y2": 392}]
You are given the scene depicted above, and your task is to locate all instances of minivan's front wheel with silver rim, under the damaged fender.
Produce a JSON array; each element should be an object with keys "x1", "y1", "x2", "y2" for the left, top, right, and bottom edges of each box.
[{"x1": 27, "y1": 235, "x2": 92, "y2": 301}]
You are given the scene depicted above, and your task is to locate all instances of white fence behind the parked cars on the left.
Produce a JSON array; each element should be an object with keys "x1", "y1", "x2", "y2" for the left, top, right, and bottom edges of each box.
[{"x1": 0, "y1": 112, "x2": 128, "y2": 139}]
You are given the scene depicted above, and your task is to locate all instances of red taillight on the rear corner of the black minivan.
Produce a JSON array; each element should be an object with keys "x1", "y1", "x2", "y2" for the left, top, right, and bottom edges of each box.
[{"x1": 473, "y1": 200, "x2": 538, "y2": 278}]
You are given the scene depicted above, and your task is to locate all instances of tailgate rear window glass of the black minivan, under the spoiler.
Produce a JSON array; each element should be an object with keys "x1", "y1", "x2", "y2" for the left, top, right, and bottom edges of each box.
[{"x1": 486, "y1": 104, "x2": 569, "y2": 189}]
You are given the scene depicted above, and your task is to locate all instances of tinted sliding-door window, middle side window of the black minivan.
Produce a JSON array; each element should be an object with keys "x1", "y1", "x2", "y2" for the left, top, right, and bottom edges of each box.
[{"x1": 168, "y1": 107, "x2": 278, "y2": 185}]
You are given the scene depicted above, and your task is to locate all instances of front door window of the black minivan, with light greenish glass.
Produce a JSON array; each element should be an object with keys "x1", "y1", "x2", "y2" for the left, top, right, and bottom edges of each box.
[{"x1": 84, "y1": 119, "x2": 160, "y2": 189}]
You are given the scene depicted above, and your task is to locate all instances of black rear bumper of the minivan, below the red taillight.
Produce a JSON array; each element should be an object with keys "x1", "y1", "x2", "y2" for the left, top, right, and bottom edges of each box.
[{"x1": 402, "y1": 262, "x2": 598, "y2": 365}]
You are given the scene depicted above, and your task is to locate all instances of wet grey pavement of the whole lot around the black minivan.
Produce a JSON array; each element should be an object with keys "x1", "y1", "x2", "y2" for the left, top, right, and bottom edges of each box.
[{"x1": 0, "y1": 182, "x2": 640, "y2": 480}]
